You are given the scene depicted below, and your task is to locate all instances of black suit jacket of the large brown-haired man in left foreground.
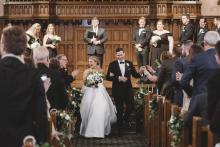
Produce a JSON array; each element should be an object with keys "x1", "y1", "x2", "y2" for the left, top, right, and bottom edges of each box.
[{"x1": 0, "y1": 57, "x2": 48, "y2": 147}]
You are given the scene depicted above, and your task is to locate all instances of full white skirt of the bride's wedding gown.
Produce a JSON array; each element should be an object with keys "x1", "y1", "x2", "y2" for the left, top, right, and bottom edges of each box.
[{"x1": 80, "y1": 83, "x2": 117, "y2": 138}]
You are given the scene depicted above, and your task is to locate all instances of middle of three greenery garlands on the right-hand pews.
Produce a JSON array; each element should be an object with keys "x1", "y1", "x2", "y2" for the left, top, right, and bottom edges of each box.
[{"x1": 148, "y1": 97, "x2": 158, "y2": 120}]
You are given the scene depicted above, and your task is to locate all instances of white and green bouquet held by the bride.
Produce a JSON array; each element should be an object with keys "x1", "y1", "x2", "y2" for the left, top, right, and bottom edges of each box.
[{"x1": 84, "y1": 72, "x2": 104, "y2": 88}]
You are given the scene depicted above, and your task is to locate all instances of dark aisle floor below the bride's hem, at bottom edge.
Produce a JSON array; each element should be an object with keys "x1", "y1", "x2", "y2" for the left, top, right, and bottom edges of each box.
[{"x1": 73, "y1": 133, "x2": 147, "y2": 147}]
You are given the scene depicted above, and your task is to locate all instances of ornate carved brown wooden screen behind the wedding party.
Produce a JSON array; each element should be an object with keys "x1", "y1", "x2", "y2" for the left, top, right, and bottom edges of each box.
[{"x1": 0, "y1": 0, "x2": 201, "y2": 82}]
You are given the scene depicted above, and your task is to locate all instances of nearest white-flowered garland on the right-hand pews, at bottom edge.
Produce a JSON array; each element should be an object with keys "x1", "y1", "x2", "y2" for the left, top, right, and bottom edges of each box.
[{"x1": 168, "y1": 113, "x2": 184, "y2": 147}]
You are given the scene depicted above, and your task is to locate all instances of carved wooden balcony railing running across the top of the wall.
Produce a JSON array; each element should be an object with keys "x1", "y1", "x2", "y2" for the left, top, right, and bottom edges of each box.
[{"x1": 4, "y1": 0, "x2": 201, "y2": 20}]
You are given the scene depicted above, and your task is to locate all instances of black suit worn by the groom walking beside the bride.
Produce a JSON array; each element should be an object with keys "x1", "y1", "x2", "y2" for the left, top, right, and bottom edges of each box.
[{"x1": 106, "y1": 60, "x2": 140, "y2": 131}]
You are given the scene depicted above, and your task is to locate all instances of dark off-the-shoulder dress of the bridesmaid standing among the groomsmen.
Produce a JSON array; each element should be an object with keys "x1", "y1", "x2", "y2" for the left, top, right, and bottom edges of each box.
[{"x1": 151, "y1": 33, "x2": 172, "y2": 69}]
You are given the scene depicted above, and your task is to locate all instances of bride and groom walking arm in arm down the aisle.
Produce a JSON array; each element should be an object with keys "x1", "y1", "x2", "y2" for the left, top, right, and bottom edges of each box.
[{"x1": 80, "y1": 48, "x2": 145, "y2": 138}]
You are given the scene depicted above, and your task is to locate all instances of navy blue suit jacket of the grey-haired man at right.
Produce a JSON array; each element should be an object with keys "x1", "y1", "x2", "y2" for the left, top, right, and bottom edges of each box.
[{"x1": 180, "y1": 48, "x2": 219, "y2": 97}]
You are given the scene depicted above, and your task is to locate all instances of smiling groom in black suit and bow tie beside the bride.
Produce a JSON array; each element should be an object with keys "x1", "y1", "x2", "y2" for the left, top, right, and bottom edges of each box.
[{"x1": 106, "y1": 48, "x2": 144, "y2": 135}]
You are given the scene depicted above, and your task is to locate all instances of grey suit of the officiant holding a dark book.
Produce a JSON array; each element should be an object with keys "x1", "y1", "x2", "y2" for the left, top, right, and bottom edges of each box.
[{"x1": 84, "y1": 28, "x2": 107, "y2": 67}]
